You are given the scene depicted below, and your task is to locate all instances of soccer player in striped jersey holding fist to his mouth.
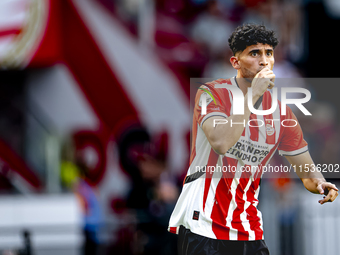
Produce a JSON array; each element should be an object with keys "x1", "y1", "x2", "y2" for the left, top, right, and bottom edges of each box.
[{"x1": 169, "y1": 24, "x2": 338, "y2": 255}]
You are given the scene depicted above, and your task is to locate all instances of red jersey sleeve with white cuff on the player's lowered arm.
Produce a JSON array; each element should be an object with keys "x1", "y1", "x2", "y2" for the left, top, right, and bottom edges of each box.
[{"x1": 278, "y1": 107, "x2": 308, "y2": 156}]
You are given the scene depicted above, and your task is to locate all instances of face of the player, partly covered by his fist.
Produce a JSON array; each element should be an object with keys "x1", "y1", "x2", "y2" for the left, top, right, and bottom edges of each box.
[{"x1": 235, "y1": 43, "x2": 274, "y2": 79}]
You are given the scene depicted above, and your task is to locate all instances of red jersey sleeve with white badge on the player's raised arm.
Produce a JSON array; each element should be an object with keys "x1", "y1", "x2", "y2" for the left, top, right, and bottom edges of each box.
[{"x1": 194, "y1": 86, "x2": 231, "y2": 127}]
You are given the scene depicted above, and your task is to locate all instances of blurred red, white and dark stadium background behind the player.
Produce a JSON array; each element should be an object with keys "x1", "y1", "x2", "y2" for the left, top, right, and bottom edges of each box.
[{"x1": 0, "y1": 0, "x2": 340, "y2": 255}]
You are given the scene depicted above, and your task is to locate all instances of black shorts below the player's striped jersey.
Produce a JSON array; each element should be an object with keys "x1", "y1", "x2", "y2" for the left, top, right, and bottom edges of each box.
[{"x1": 178, "y1": 226, "x2": 269, "y2": 255}]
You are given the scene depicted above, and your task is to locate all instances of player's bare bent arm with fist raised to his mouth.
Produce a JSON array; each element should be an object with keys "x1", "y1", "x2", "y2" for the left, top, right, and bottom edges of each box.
[{"x1": 202, "y1": 68, "x2": 275, "y2": 154}]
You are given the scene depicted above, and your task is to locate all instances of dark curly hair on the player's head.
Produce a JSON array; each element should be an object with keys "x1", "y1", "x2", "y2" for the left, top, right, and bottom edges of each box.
[{"x1": 228, "y1": 24, "x2": 279, "y2": 55}]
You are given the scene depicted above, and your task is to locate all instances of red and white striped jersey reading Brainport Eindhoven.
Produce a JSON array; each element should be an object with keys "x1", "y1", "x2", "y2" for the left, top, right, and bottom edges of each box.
[{"x1": 168, "y1": 78, "x2": 308, "y2": 240}]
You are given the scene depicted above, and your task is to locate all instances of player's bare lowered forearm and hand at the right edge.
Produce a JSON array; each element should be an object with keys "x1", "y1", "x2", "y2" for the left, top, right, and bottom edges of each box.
[{"x1": 286, "y1": 151, "x2": 338, "y2": 204}]
